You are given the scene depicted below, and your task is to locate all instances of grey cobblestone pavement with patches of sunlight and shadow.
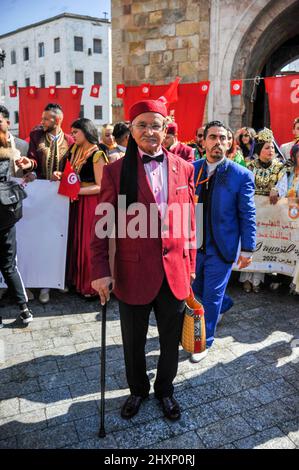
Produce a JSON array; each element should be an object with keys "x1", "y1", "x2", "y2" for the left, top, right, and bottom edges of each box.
[{"x1": 0, "y1": 280, "x2": 299, "y2": 449}]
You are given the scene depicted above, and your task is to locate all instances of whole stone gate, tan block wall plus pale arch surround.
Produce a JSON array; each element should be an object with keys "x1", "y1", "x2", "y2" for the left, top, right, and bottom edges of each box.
[{"x1": 112, "y1": 0, "x2": 299, "y2": 128}]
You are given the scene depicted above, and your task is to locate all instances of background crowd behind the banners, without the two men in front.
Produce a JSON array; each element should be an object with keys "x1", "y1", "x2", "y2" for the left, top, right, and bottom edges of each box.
[{"x1": 0, "y1": 103, "x2": 299, "y2": 310}]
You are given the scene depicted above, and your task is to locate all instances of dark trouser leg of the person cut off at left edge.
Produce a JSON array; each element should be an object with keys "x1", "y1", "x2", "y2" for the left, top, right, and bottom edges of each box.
[{"x1": 0, "y1": 225, "x2": 28, "y2": 305}]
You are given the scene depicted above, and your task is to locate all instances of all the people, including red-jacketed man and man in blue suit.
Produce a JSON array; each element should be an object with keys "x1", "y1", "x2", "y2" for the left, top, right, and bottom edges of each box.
[{"x1": 0, "y1": 100, "x2": 299, "y2": 419}]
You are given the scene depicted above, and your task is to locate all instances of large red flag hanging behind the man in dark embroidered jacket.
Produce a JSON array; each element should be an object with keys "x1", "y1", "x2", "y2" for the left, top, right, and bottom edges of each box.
[{"x1": 19, "y1": 87, "x2": 83, "y2": 139}]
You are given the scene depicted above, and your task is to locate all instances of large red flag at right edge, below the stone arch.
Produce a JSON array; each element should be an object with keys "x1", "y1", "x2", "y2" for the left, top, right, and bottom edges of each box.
[{"x1": 265, "y1": 74, "x2": 299, "y2": 145}]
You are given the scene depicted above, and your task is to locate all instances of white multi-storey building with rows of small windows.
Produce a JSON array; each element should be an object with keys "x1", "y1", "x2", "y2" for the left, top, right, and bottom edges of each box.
[{"x1": 0, "y1": 13, "x2": 112, "y2": 135}]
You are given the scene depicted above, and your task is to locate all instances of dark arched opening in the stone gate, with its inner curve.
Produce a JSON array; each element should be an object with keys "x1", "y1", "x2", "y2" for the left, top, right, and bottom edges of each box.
[{"x1": 229, "y1": 0, "x2": 299, "y2": 128}]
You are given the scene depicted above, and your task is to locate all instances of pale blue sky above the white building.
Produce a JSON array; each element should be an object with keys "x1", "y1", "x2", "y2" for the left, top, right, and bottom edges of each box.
[{"x1": 0, "y1": 0, "x2": 111, "y2": 35}]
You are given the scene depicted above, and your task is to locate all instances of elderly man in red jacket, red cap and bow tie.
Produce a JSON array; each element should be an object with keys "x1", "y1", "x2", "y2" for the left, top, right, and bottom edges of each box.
[{"x1": 91, "y1": 100, "x2": 196, "y2": 420}]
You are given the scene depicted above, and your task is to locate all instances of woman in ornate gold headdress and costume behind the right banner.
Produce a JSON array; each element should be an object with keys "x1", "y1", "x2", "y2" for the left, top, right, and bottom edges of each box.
[{"x1": 240, "y1": 128, "x2": 286, "y2": 293}]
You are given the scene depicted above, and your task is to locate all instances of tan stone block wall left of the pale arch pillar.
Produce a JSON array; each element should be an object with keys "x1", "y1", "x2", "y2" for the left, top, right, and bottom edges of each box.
[{"x1": 112, "y1": 0, "x2": 210, "y2": 120}]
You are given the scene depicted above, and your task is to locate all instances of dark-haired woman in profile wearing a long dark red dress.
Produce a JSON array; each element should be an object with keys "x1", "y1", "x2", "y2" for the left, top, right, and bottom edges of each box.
[{"x1": 55, "y1": 118, "x2": 108, "y2": 298}]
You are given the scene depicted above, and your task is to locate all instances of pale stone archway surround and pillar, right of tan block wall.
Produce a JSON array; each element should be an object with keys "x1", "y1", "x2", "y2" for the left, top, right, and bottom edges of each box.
[{"x1": 209, "y1": 0, "x2": 299, "y2": 128}]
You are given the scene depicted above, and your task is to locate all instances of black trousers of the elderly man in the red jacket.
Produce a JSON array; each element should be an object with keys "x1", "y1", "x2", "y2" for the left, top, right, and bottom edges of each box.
[{"x1": 119, "y1": 279, "x2": 185, "y2": 398}]
